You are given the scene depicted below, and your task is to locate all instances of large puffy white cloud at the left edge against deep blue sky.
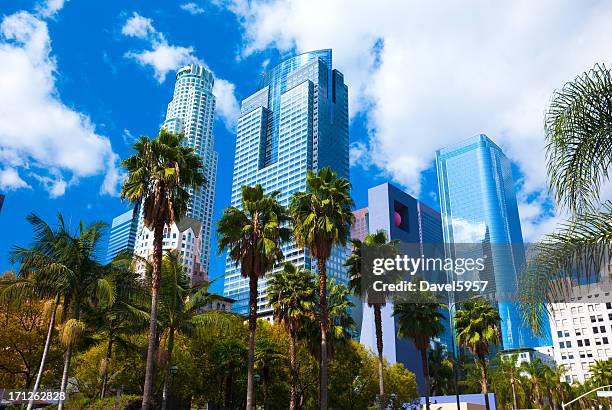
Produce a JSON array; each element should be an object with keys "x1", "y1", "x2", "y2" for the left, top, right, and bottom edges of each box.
[{"x1": 0, "y1": 9, "x2": 122, "y2": 196}]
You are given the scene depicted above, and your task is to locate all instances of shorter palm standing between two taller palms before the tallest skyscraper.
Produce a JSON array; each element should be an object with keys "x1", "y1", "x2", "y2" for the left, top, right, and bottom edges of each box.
[{"x1": 268, "y1": 262, "x2": 315, "y2": 410}]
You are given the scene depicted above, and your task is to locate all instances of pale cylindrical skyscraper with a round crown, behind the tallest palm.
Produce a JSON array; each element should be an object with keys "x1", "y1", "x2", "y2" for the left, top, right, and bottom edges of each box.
[{"x1": 136, "y1": 64, "x2": 217, "y2": 275}]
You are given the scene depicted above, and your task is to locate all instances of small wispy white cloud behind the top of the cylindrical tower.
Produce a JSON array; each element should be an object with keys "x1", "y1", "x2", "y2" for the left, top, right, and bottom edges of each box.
[{"x1": 121, "y1": 13, "x2": 240, "y2": 131}]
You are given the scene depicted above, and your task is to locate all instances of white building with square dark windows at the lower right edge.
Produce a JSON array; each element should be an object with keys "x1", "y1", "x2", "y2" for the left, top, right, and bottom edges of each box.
[{"x1": 550, "y1": 278, "x2": 612, "y2": 383}]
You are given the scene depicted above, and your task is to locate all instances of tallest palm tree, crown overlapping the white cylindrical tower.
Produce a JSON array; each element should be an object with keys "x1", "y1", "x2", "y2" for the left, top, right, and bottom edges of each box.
[{"x1": 121, "y1": 129, "x2": 204, "y2": 410}]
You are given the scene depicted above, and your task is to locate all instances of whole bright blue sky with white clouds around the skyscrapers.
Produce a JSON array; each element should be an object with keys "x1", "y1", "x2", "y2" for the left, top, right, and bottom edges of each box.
[{"x1": 0, "y1": 0, "x2": 612, "y2": 294}]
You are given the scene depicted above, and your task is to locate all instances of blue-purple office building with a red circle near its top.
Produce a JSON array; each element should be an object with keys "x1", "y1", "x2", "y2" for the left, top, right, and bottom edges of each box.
[{"x1": 351, "y1": 183, "x2": 450, "y2": 393}]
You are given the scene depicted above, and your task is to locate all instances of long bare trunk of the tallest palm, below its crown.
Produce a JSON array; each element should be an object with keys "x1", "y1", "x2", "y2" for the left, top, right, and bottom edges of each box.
[{"x1": 142, "y1": 221, "x2": 164, "y2": 410}]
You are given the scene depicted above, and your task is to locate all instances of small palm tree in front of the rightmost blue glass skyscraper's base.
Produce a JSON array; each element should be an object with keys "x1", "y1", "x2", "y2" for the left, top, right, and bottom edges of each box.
[{"x1": 455, "y1": 299, "x2": 501, "y2": 410}]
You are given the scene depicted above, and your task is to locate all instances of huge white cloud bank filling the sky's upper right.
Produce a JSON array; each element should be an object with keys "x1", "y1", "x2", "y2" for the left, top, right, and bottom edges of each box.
[{"x1": 219, "y1": 0, "x2": 612, "y2": 234}]
